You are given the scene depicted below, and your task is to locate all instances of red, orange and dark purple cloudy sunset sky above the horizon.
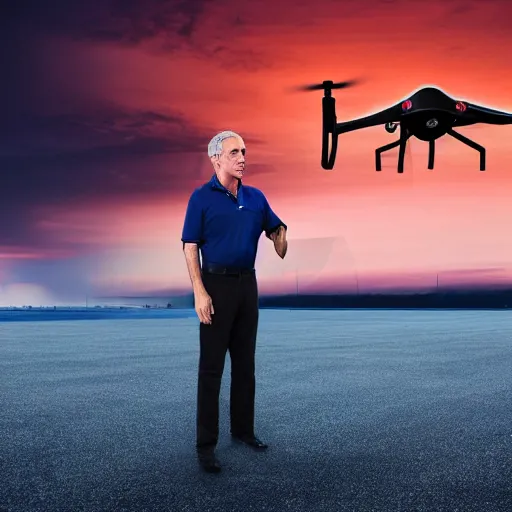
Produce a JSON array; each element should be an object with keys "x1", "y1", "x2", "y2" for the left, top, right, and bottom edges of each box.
[{"x1": 0, "y1": 0, "x2": 512, "y2": 306}]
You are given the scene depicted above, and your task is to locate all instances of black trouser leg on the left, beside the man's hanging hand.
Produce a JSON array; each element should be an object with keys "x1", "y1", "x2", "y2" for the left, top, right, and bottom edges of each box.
[{"x1": 196, "y1": 275, "x2": 237, "y2": 452}]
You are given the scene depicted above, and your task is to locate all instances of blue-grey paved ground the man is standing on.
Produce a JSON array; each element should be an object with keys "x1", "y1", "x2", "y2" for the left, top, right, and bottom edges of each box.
[{"x1": 0, "y1": 310, "x2": 512, "y2": 512}]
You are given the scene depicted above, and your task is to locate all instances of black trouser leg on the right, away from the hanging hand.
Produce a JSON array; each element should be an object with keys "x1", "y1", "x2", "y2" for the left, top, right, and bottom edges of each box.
[{"x1": 229, "y1": 276, "x2": 259, "y2": 436}]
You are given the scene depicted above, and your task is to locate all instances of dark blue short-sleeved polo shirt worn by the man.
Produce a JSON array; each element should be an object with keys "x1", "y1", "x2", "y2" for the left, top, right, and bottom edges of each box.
[{"x1": 181, "y1": 174, "x2": 286, "y2": 268}]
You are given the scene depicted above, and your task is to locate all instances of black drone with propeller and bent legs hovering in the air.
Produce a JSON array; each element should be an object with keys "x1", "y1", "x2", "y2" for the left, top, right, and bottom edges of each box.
[{"x1": 300, "y1": 80, "x2": 512, "y2": 173}]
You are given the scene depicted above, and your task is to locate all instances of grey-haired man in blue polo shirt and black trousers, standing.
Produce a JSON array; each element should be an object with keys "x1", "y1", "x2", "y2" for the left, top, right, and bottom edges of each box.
[{"x1": 182, "y1": 131, "x2": 287, "y2": 472}]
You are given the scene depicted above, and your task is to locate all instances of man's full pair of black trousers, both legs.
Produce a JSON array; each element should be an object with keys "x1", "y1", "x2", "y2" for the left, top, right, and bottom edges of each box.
[{"x1": 196, "y1": 274, "x2": 259, "y2": 452}]
